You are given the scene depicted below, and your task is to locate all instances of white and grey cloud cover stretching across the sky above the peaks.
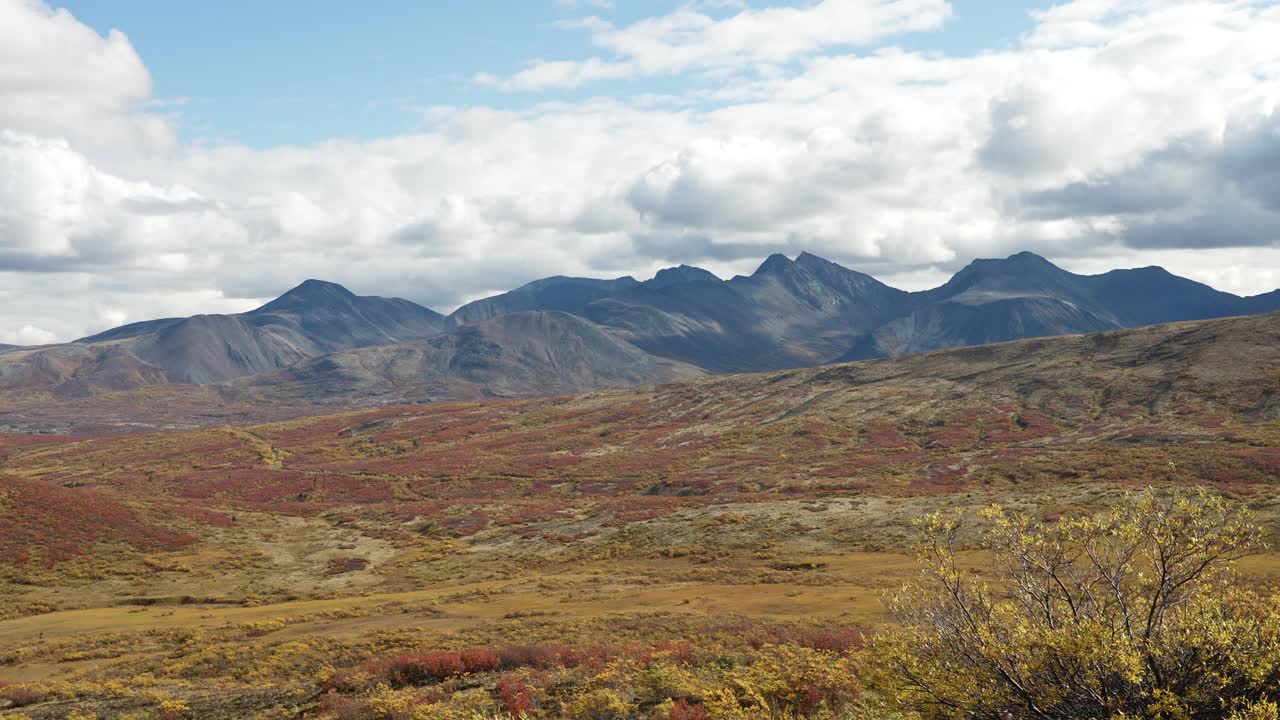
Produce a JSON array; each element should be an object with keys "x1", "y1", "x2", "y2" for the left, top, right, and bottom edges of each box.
[{"x1": 0, "y1": 0, "x2": 1280, "y2": 342}]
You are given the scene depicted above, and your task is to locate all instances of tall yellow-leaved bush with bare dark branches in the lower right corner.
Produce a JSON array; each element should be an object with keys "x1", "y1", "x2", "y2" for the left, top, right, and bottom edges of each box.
[{"x1": 867, "y1": 491, "x2": 1280, "y2": 720}]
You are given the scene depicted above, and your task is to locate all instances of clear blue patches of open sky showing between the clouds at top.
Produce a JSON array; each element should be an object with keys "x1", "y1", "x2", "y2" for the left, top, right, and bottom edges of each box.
[{"x1": 58, "y1": 0, "x2": 1051, "y2": 147}]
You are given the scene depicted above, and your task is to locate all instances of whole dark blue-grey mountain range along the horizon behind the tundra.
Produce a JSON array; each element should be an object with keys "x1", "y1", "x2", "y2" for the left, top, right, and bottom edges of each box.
[{"x1": 0, "y1": 252, "x2": 1280, "y2": 405}]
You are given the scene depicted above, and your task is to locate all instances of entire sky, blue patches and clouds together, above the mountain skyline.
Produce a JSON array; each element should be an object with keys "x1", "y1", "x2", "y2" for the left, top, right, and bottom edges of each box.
[{"x1": 0, "y1": 0, "x2": 1280, "y2": 345}]
